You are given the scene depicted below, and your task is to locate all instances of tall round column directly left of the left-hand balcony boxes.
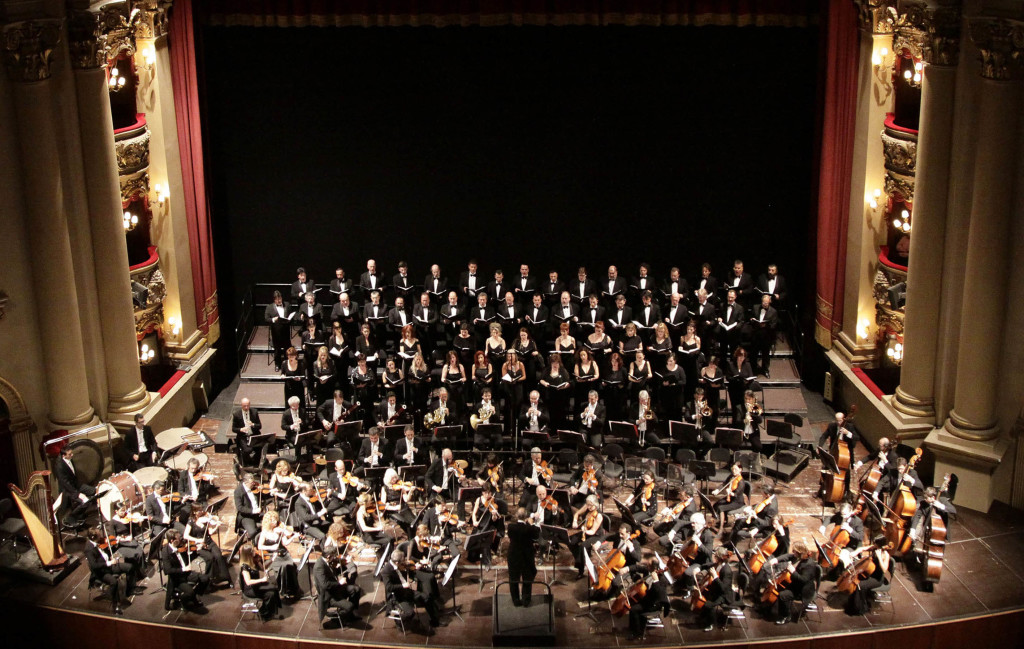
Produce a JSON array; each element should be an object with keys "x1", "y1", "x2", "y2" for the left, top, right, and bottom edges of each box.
[{"x1": 68, "y1": 11, "x2": 150, "y2": 415}]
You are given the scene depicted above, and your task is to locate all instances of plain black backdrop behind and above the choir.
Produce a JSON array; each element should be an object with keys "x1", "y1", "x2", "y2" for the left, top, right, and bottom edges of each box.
[{"x1": 201, "y1": 27, "x2": 818, "y2": 376}]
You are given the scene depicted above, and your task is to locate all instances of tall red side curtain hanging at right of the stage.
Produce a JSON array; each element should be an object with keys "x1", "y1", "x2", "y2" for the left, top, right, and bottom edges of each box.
[{"x1": 814, "y1": 0, "x2": 860, "y2": 349}]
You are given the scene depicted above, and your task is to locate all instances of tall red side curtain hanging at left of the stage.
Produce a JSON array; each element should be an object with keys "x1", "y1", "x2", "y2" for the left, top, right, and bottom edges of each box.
[{"x1": 167, "y1": 0, "x2": 219, "y2": 343}]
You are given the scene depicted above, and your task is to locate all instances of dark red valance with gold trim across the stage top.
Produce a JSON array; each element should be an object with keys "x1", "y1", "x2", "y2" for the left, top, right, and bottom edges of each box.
[{"x1": 203, "y1": 0, "x2": 821, "y2": 27}]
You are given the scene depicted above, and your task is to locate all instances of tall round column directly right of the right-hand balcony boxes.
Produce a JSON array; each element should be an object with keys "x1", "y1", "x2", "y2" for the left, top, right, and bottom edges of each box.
[{"x1": 893, "y1": 0, "x2": 961, "y2": 418}]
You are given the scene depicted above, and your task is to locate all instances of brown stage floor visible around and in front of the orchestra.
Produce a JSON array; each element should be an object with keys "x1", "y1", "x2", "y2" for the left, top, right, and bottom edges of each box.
[{"x1": 0, "y1": 419, "x2": 1024, "y2": 647}]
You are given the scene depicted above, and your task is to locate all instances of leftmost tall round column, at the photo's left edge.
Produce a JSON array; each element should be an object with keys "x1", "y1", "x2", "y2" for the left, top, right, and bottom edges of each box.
[{"x1": 0, "y1": 19, "x2": 96, "y2": 428}]
